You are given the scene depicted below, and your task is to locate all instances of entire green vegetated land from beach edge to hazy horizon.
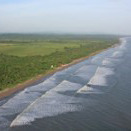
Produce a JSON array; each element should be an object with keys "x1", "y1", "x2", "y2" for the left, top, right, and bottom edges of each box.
[{"x1": 0, "y1": 34, "x2": 119, "y2": 90}]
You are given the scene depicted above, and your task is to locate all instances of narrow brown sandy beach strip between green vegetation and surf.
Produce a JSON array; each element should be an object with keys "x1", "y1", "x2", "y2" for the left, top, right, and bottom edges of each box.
[{"x1": 0, "y1": 42, "x2": 121, "y2": 100}]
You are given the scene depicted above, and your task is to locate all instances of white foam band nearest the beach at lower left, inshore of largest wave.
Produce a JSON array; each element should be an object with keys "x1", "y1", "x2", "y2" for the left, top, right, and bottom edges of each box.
[{"x1": 0, "y1": 79, "x2": 56, "y2": 117}]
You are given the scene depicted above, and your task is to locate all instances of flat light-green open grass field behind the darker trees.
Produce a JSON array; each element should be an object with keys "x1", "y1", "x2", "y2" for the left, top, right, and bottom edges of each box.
[{"x1": 0, "y1": 42, "x2": 79, "y2": 56}]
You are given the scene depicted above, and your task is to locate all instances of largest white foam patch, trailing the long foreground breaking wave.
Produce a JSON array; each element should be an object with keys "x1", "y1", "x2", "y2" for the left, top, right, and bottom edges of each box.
[{"x1": 11, "y1": 81, "x2": 81, "y2": 126}]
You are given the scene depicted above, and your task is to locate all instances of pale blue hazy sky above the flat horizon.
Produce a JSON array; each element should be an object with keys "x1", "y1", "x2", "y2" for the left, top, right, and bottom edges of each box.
[{"x1": 0, "y1": 0, "x2": 131, "y2": 35}]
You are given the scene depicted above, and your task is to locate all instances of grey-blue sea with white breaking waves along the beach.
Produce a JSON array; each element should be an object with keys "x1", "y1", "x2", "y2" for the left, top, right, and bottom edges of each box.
[{"x1": 0, "y1": 38, "x2": 131, "y2": 131}]
